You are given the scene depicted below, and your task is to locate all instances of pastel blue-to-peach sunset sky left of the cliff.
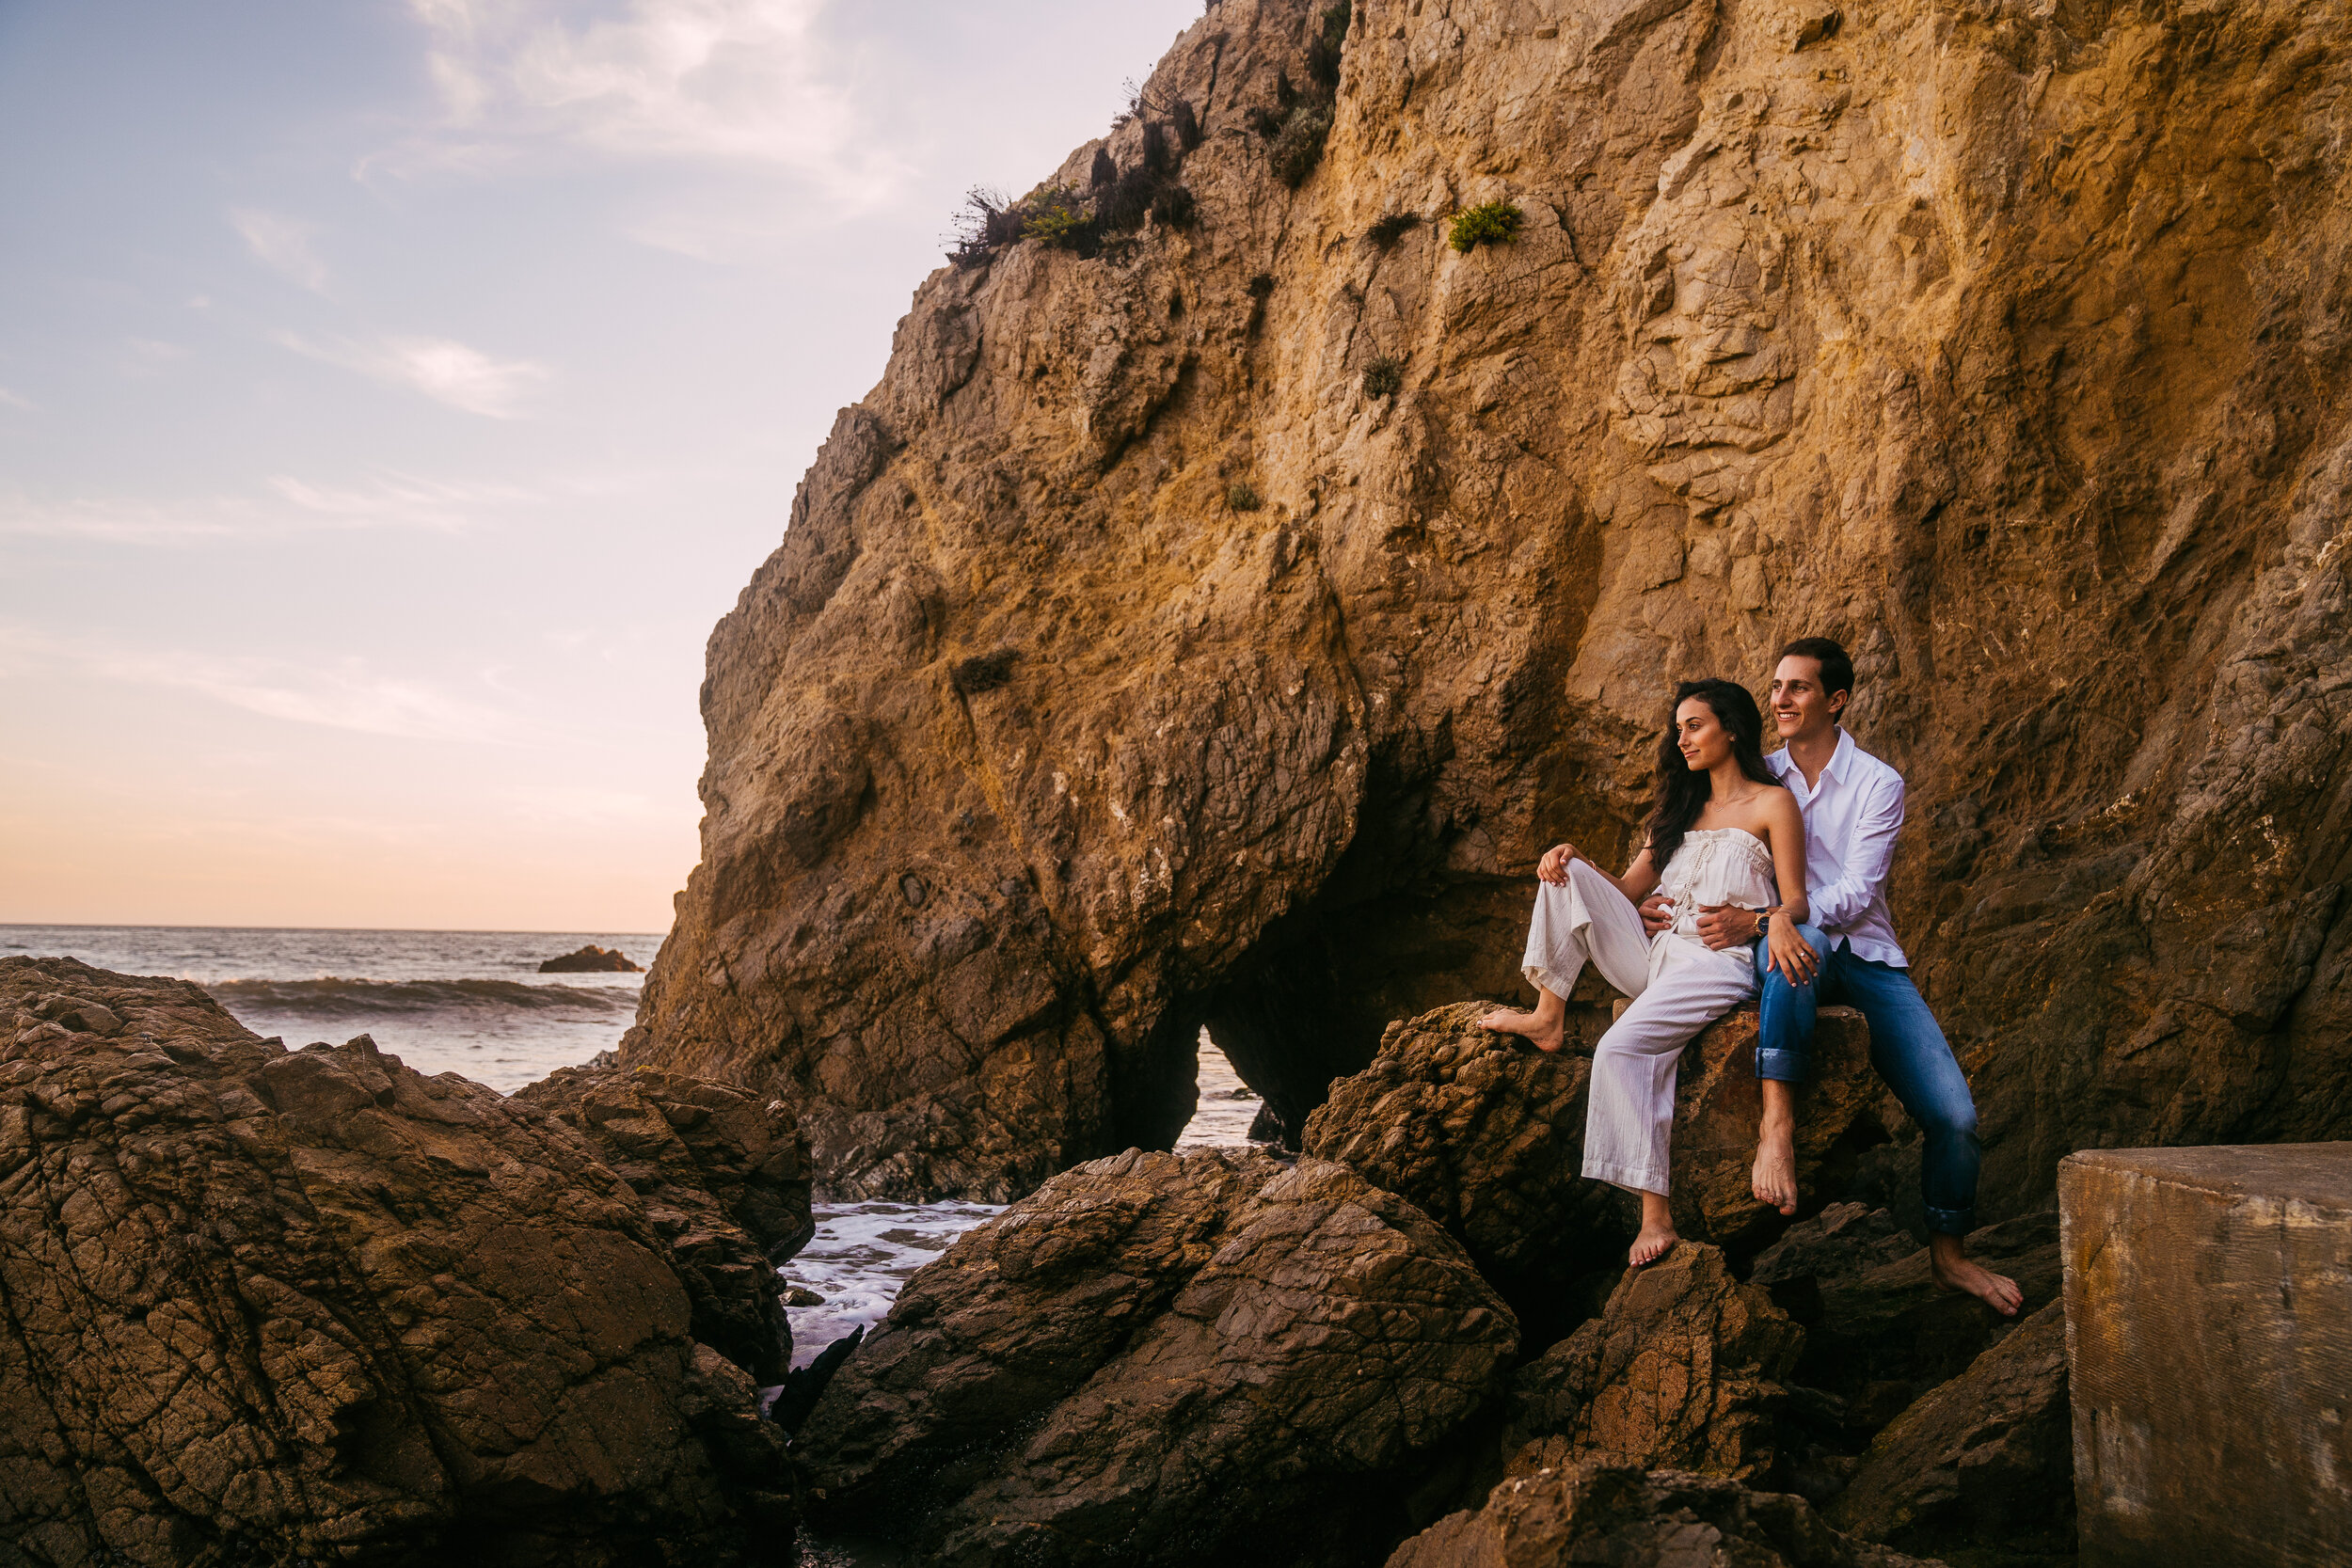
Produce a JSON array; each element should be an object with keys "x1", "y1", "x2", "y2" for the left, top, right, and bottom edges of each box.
[{"x1": 0, "y1": 0, "x2": 1200, "y2": 931}]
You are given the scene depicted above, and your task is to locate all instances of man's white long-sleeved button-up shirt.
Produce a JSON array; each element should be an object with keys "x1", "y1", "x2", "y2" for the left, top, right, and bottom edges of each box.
[{"x1": 1764, "y1": 726, "x2": 1910, "y2": 969}]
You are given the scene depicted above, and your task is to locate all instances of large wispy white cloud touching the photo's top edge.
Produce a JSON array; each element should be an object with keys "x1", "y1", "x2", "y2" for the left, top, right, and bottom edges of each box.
[{"x1": 376, "y1": 0, "x2": 906, "y2": 199}]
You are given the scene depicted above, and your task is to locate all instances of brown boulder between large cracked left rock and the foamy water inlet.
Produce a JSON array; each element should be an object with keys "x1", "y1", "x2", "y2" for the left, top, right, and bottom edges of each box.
[{"x1": 513, "y1": 1068, "x2": 817, "y2": 1385}]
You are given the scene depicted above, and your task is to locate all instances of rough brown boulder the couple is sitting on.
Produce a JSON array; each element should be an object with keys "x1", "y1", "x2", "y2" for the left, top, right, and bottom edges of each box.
[{"x1": 1303, "y1": 1002, "x2": 1884, "y2": 1322}]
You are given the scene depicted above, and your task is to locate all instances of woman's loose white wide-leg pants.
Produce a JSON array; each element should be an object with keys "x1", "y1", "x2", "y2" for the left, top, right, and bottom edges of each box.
[{"x1": 1522, "y1": 861, "x2": 1757, "y2": 1195}]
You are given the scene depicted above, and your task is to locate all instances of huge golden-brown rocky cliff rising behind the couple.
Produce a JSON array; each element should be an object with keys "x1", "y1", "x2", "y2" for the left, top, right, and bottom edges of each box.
[{"x1": 624, "y1": 0, "x2": 2352, "y2": 1218}]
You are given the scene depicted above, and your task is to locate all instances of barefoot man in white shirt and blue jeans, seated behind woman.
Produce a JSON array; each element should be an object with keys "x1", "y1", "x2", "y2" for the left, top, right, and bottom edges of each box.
[{"x1": 1642, "y1": 637, "x2": 2026, "y2": 1317}]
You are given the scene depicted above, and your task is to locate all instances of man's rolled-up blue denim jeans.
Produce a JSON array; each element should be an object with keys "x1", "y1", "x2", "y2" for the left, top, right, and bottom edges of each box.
[{"x1": 1757, "y1": 927, "x2": 1983, "y2": 1237}]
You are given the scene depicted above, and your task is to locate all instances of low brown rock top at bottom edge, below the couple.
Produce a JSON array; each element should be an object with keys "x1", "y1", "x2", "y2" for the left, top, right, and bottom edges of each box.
[{"x1": 1388, "y1": 1465, "x2": 1919, "y2": 1568}]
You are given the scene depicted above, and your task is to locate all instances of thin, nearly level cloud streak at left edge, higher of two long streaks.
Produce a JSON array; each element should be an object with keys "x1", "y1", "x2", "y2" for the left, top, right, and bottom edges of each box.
[{"x1": 0, "y1": 475, "x2": 544, "y2": 546}]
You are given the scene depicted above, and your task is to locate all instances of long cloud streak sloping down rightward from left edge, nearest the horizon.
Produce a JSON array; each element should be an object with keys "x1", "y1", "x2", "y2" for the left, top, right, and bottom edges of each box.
[{"x1": 0, "y1": 627, "x2": 541, "y2": 743}]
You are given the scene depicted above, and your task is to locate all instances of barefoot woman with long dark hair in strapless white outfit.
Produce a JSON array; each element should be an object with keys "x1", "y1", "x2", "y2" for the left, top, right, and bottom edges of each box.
[{"x1": 1480, "y1": 679, "x2": 1814, "y2": 1267}]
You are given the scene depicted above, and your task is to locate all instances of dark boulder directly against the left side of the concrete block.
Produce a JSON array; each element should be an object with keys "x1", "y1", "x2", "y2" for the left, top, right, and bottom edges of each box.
[{"x1": 1828, "y1": 1303, "x2": 2074, "y2": 1557}]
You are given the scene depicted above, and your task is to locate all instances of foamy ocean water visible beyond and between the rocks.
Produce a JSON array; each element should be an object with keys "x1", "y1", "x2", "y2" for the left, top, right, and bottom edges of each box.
[{"x1": 0, "y1": 927, "x2": 1259, "y2": 1364}]
